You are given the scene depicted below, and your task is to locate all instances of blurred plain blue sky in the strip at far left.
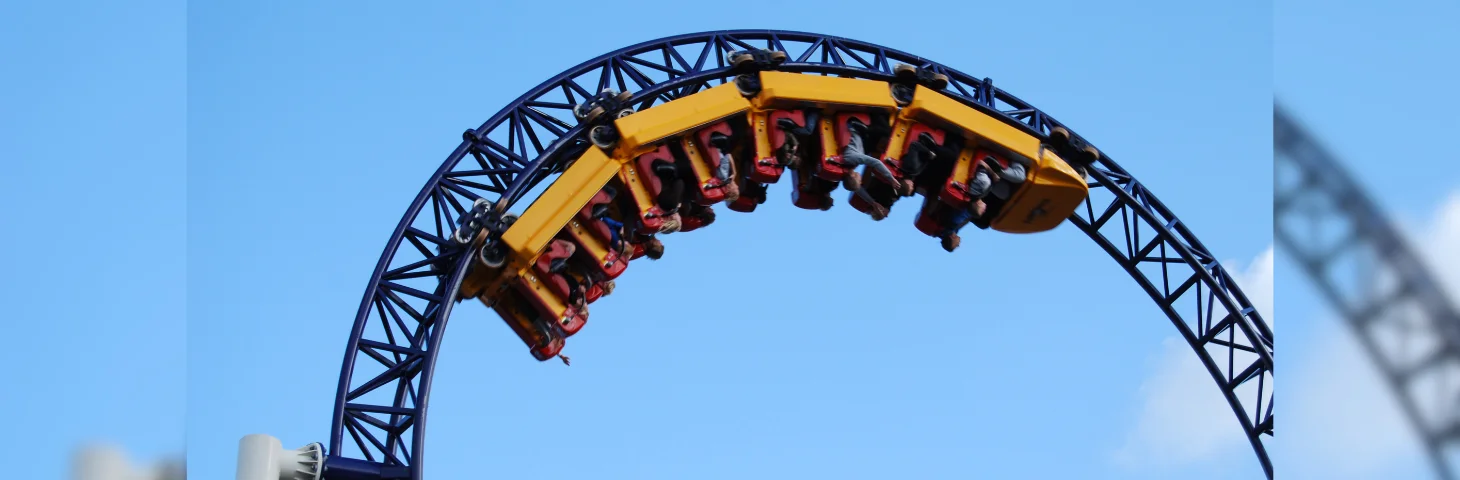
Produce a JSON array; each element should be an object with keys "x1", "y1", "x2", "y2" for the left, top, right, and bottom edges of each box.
[{"x1": 0, "y1": 0, "x2": 187, "y2": 479}]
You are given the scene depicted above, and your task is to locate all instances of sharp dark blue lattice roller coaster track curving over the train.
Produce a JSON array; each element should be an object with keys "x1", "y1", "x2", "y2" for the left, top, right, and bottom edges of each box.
[{"x1": 316, "y1": 31, "x2": 1273, "y2": 480}]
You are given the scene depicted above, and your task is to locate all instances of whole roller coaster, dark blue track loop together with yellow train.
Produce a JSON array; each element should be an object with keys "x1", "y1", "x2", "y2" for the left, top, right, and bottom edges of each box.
[{"x1": 239, "y1": 31, "x2": 1273, "y2": 480}]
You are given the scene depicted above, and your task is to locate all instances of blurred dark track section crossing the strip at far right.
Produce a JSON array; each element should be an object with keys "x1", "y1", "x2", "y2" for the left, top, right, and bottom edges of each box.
[{"x1": 1273, "y1": 105, "x2": 1460, "y2": 480}]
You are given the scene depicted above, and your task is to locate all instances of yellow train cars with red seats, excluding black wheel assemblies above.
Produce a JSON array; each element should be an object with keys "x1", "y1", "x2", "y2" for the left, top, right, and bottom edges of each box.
[{"x1": 473, "y1": 71, "x2": 1089, "y2": 360}]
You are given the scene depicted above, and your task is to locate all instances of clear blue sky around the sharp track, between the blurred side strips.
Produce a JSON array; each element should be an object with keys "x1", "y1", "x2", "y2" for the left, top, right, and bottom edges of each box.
[{"x1": 187, "y1": 1, "x2": 1272, "y2": 479}]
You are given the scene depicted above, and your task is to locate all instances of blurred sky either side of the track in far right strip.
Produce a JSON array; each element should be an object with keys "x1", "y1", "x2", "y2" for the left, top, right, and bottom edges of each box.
[{"x1": 1273, "y1": 0, "x2": 1460, "y2": 479}]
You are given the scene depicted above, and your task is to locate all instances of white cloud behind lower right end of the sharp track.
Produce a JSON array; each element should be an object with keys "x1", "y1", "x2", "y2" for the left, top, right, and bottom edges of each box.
[{"x1": 1115, "y1": 247, "x2": 1273, "y2": 468}]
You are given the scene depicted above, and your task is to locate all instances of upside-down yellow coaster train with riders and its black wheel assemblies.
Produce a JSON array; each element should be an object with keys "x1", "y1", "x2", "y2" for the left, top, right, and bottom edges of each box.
[{"x1": 467, "y1": 64, "x2": 1099, "y2": 360}]
